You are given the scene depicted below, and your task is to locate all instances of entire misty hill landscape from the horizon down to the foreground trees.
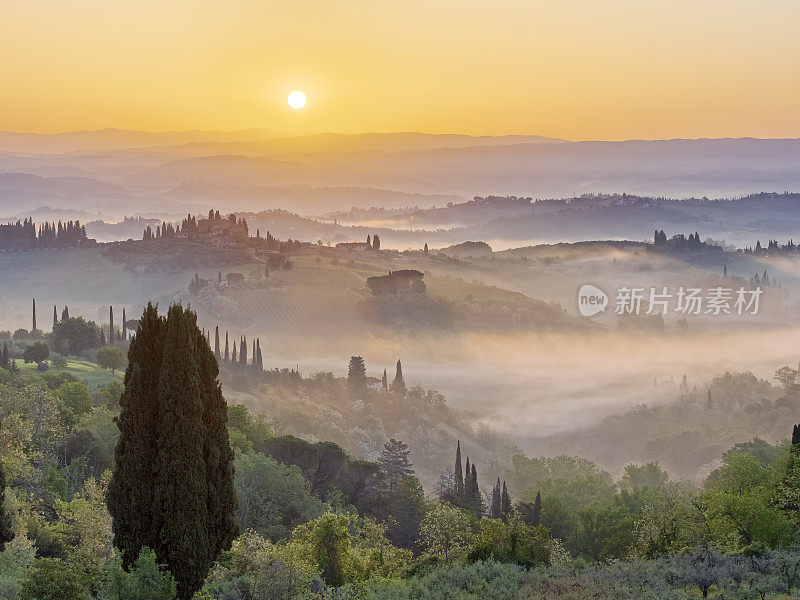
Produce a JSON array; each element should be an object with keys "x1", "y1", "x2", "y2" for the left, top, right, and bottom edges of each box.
[{"x1": 0, "y1": 130, "x2": 800, "y2": 474}]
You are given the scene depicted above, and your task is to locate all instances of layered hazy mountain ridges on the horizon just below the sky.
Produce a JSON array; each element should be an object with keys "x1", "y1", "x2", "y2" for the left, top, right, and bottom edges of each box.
[{"x1": 0, "y1": 130, "x2": 800, "y2": 219}]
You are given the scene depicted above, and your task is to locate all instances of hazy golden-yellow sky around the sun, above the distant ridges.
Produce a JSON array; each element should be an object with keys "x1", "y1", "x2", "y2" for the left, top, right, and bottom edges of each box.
[{"x1": 0, "y1": 0, "x2": 800, "y2": 139}]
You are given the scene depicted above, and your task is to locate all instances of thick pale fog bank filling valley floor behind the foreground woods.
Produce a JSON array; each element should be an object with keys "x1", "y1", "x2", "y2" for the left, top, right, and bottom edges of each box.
[{"x1": 264, "y1": 324, "x2": 800, "y2": 452}]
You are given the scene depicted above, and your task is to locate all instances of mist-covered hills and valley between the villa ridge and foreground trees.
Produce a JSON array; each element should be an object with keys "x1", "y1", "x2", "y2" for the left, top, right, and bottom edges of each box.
[{"x1": 0, "y1": 232, "x2": 800, "y2": 472}]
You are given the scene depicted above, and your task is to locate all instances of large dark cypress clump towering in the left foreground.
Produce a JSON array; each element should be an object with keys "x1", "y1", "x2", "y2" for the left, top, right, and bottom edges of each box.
[{"x1": 108, "y1": 305, "x2": 236, "y2": 599}]
